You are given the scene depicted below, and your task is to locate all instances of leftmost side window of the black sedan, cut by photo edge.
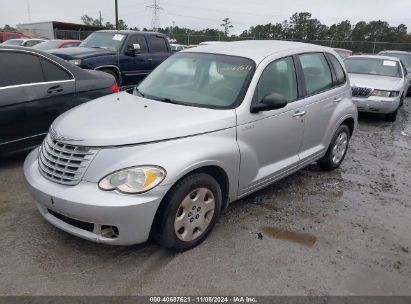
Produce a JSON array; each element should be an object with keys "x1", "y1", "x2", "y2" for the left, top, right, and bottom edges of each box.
[{"x1": 0, "y1": 51, "x2": 44, "y2": 87}]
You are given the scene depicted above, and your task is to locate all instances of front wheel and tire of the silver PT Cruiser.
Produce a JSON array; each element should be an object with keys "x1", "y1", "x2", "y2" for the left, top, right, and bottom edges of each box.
[{"x1": 153, "y1": 173, "x2": 222, "y2": 252}]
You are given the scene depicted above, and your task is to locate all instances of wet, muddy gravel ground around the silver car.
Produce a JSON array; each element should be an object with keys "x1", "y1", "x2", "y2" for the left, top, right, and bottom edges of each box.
[{"x1": 0, "y1": 98, "x2": 411, "y2": 295}]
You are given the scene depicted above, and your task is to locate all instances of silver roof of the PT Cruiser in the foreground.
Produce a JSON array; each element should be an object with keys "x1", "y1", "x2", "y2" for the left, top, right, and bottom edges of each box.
[{"x1": 181, "y1": 40, "x2": 334, "y2": 63}]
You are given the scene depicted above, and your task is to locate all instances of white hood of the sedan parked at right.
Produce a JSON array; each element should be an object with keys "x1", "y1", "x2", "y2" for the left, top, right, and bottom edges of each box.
[{"x1": 349, "y1": 74, "x2": 402, "y2": 91}]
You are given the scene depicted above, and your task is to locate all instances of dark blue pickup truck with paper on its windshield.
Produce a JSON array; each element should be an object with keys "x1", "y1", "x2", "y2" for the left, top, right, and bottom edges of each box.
[{"x1": 49, "y1": 30, "x2": 172, "y2": 87}]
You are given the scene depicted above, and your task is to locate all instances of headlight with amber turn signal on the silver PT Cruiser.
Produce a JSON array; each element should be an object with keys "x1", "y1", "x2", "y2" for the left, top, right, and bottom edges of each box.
[{"x1": 98, "y1": 166, "x2": 166, "y2": 194}]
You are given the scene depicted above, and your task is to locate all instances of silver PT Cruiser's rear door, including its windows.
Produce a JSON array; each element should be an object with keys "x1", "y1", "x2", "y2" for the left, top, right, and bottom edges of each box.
[{"x1": 298, "y1": 52, "x2": 350, "y2": 163}]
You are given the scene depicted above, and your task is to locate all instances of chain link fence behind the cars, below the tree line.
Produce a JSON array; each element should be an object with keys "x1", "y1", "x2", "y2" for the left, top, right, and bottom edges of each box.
[{"x1": 170, "y1": 34, "x2": 411, "y2": 54}]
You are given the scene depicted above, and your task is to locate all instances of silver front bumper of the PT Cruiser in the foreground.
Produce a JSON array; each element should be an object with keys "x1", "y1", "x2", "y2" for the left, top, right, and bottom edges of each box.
[{"x1": 24, "y1": 149, "x2": 168, "y2": 245}]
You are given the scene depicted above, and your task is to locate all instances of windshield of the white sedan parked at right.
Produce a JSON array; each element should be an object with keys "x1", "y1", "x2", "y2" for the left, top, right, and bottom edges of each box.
[{"x1": 344, "y1": 58, "x2": 402, "y2": 78}]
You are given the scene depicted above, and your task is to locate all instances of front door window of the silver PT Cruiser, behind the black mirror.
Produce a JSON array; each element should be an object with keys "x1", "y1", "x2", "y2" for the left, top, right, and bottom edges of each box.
[{"x1": 256, "y1": 57, "x2": 298, "y2": 102}]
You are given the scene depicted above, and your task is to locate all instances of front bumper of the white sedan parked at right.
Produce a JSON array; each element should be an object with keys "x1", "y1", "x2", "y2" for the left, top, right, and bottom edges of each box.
[{"x1": 352, "y1": 96, "x2": 401, "y2": 114}]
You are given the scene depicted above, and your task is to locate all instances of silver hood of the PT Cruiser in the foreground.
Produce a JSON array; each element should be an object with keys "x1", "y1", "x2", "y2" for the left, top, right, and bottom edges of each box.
[{"x1": 52, "y1": 92, "x2": 236, "y2": 147}]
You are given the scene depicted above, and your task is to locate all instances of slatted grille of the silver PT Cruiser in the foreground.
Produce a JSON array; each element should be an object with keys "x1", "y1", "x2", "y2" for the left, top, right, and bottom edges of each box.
[{"x1": 39, "y1": 135, "x2": 97, "y2": 186}]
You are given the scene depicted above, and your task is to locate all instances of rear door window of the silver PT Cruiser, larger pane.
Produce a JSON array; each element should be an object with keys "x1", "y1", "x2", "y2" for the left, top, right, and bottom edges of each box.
[{"x1": 299, "y1": 53, "x2": 332, "y2": 95}]
